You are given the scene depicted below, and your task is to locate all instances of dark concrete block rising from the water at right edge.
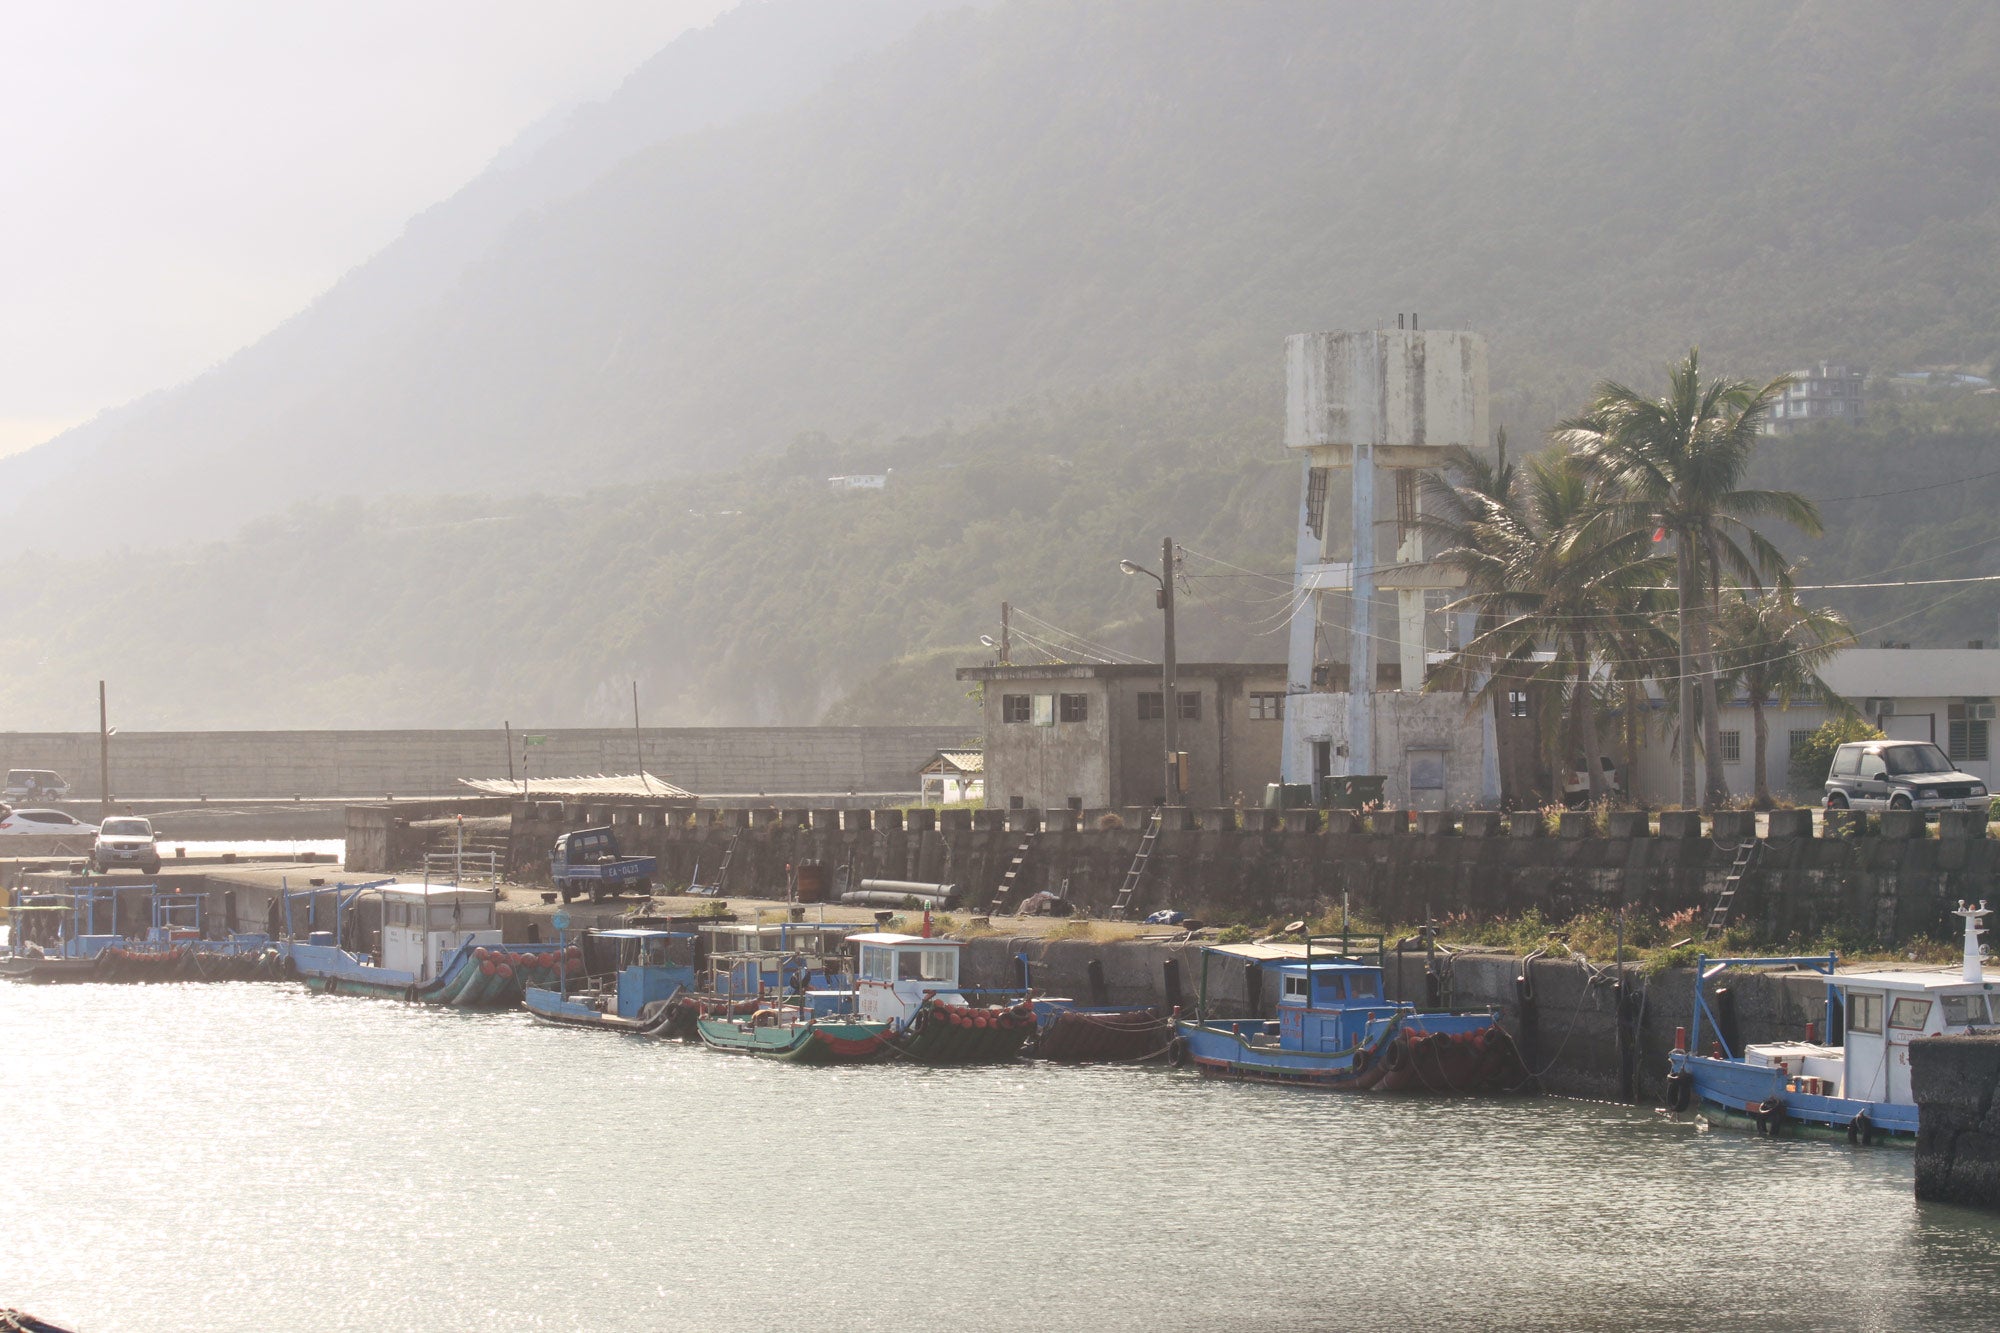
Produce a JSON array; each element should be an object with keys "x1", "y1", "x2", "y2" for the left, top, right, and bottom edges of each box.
[{"x1": 1910, "y1": 1037, "x2": 2000, "y2": 1209}]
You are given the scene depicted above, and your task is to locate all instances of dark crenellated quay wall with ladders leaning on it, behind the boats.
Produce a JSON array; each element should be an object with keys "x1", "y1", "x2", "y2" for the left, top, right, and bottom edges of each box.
[{"x1": 476, "y1": 801, "x2": 2000, "y2": 947}]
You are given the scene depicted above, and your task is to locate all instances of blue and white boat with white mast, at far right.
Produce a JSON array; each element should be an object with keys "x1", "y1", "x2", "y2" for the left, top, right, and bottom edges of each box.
[{"x1": 1666, "y1": 903, "x2": 2000, "y2": 1145}]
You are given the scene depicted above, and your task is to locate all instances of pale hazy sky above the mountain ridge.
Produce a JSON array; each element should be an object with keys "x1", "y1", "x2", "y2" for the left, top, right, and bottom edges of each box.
[{"x1": 0, "y1": 0, "x2": 732, "y2": 454}]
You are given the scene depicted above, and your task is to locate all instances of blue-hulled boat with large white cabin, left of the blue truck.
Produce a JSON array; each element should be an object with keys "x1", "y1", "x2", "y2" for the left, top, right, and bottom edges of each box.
[{"x1": 278, "y1": 881, "x2": 562, "y2": 1009}]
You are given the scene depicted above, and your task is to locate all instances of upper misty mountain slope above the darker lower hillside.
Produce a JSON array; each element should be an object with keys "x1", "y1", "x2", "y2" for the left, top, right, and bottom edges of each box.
[{"x1": 0, "y1": 0, "x2": 2000, "y2": 548}]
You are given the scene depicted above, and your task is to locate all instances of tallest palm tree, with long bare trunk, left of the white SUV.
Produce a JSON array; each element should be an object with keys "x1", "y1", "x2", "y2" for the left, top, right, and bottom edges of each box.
[{"x1": 1552, "y1": 348, "x2": 1820, "y2": 807}]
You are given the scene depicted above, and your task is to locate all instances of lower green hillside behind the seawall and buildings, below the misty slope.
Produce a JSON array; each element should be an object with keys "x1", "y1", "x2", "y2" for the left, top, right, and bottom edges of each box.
[{"x1": 0, "y1": 382, "x2": 2000, "y2": 729}]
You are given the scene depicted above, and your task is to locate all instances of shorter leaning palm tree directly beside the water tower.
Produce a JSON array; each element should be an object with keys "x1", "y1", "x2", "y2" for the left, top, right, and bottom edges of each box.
[{"x1": 1420, "y1": 450, "x2": 1664, "y2": 801}]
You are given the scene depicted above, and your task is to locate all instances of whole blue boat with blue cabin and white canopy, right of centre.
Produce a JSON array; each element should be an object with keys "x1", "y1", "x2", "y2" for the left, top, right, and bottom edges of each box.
[{"x1": 1172, "y1": 939, "x2": 1528, "y2": 1095}]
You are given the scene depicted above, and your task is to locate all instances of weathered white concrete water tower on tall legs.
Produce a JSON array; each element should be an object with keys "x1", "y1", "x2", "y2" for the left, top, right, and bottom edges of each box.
[{"x1": 1282, "y1": 316, "x2": 1498, "y2": 799}]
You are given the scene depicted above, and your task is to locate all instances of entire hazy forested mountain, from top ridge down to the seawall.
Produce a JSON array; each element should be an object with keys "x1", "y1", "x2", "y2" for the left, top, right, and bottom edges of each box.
[{"x1": 0, "y1": 0, "x2": 2000, "y2": 727}]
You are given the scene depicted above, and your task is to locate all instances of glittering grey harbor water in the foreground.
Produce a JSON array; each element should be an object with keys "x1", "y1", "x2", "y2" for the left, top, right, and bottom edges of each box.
[{"x1": 0, "y1": 983, "x2": 2000, "y2": 1333}]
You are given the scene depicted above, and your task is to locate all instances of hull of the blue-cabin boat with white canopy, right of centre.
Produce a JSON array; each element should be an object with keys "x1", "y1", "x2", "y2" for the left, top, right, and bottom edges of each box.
[{"x1": 1174, "y1": 1021, "x2": 1530, "y2": 1097}]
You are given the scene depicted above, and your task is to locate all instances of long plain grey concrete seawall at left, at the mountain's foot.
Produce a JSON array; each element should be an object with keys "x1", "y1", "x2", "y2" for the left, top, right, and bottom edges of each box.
[{"x1": 0, "y1": 727, "x2": 966, "y2": 799}]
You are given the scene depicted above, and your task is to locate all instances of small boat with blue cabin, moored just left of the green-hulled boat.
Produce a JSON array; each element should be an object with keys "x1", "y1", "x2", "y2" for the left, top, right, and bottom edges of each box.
[{"x1": 522, "y1": 927, "x2": 696, "y2": 1037}]
